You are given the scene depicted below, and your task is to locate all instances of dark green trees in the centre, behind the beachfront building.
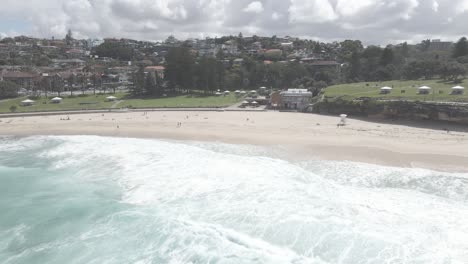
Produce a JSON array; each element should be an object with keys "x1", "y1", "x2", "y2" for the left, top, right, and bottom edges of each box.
[{"x1": 132, "y1": 47, "x2": 339, "y2": 95}]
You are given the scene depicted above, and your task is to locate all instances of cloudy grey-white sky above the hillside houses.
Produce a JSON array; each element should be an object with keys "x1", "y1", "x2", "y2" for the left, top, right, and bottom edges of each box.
[{"x1": 0, "y1": 0, "x2": 468, "y2": 44}]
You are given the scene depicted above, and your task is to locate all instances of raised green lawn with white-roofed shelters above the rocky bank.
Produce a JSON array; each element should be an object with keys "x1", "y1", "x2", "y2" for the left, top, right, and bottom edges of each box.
[{"x1": 325, "y1": 80, "x2": 468, "y2": 102}]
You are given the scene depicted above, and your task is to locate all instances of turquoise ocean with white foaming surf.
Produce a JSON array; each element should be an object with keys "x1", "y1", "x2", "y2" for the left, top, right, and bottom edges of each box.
[{"x1": 0, "y1": 136, "x2": 468, "y2": 264}]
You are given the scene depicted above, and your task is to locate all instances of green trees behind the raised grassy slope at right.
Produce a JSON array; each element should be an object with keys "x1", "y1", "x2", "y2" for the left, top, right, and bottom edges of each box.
[{"x1": 340, "y1": 37, "x2": 468, "y2": 82}]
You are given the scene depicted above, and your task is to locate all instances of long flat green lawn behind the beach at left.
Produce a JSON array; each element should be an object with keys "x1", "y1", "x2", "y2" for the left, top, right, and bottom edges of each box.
[{"x1": 0, "y1": 93, "x2": 241, "y2": 113}]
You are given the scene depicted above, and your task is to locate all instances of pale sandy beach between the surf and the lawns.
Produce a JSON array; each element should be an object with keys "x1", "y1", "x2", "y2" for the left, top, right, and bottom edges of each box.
[{"x1": 0, "y1": 111, "x2": 468, "y2": 172}]
